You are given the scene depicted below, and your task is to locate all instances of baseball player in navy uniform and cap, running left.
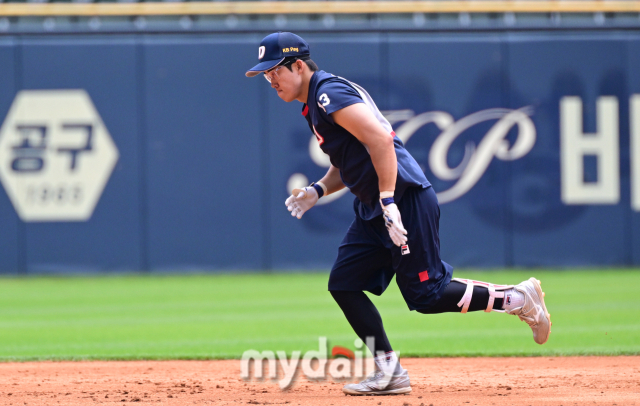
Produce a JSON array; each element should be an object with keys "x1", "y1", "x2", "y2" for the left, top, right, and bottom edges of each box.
[{"x1": 246, "y1": 32, "x2": 551, "y2": 395}]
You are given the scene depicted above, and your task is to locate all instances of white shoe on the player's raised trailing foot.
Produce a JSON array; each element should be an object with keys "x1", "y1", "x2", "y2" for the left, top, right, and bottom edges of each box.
[{"x1": 507, "y1": 278, "x2": 551, "y2": 344}]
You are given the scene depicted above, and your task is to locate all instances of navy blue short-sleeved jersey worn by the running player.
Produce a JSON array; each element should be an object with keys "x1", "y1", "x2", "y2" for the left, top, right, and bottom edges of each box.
[{"x1": 302, "y1": 71, "x2": 431, "y2": 220}]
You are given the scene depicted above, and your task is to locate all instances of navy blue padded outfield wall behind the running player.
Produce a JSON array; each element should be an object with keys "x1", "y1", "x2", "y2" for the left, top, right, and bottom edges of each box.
[{"x1": 0, "y1": 31, "x2": 640, "y2": 273}]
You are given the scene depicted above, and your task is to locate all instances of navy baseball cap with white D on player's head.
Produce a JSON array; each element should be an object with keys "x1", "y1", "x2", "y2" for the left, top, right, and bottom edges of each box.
[{"x1": 245, "y1": 32, "x2": 309, "y2": 77}]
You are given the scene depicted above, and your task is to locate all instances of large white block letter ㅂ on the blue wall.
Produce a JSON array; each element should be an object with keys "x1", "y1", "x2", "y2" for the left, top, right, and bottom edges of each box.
[{"x1": 560, "y1": 96, "x2": 620, "y2": 204}]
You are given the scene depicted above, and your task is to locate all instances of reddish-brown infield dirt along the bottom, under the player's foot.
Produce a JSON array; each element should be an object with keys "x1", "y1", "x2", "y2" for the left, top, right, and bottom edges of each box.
[{"x1": 0, "y1": 356, "x2": 640, "y2": 406}]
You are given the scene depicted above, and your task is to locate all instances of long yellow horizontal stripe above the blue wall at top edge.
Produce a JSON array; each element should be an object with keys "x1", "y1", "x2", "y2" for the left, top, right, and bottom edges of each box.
[{"x1": 0, "y1": 0, "x2": 640, "y2": 16}]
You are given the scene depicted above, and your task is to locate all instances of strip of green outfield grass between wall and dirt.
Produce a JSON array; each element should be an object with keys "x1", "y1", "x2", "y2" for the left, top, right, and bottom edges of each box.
[{"x1": 0, "y1": 269, "x2": 640, "y2": 361}]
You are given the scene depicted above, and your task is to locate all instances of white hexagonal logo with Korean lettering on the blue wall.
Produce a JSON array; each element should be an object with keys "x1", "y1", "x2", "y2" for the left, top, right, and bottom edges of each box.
[{"x1": 0, "y1": 90, "x2": 118, "y2": 221}]
